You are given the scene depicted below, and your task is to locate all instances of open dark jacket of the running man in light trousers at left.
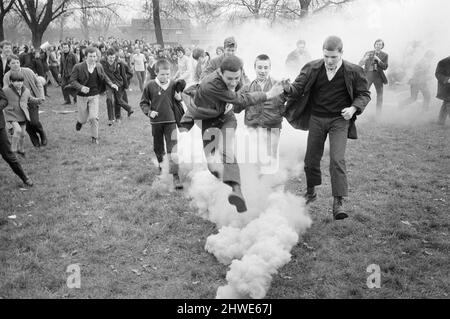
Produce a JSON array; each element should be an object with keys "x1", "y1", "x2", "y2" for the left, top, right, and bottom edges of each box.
[{"x1": 64, "y1": 61, "x2": 113, "y2": 93}]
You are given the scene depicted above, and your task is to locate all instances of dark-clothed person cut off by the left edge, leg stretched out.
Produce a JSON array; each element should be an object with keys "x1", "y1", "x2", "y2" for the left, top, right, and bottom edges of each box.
[{"x1": 0, "y1": 87, "x2": 33, "y2": 187}]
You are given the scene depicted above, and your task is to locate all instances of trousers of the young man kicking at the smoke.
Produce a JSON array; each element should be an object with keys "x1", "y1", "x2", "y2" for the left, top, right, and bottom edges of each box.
[{"x1": 202, "y1": 112, "x2": 241, "y2": 185}]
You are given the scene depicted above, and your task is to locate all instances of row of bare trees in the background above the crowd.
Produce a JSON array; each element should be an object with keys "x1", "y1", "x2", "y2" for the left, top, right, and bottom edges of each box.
[{"x1": 0, "y1": 0, "x2": 355, "y2": 47}]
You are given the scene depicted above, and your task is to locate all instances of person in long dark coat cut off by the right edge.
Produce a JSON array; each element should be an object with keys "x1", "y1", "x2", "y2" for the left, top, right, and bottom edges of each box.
[{"x1": 435, "y1": 56, "x2": 450, "y2": 125}]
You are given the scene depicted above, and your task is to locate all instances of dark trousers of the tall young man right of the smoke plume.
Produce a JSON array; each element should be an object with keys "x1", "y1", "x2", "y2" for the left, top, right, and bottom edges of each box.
[{"x1": 305, "y1": 115, "x2": 349, "y2": 196}]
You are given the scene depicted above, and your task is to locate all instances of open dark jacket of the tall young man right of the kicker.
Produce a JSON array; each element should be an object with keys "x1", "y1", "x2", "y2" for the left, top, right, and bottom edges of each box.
[{"x1": 283, "y1": 59, "x2": 370, "y2": 139}]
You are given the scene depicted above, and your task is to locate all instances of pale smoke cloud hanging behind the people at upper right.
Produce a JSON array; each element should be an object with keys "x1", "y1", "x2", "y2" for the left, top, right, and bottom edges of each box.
[{"x1": 208, "y1": 0, "x2": 450, "y2": 126}]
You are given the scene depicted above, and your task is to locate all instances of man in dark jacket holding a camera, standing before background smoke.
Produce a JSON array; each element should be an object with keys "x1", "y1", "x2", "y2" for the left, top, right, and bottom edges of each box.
[{"x1": 359, "y1": 39, "x2": 388, "y2": 115}]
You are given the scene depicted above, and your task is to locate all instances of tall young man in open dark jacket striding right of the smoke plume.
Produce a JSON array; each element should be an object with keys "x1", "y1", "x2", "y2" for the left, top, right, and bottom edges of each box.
[{"x1": 282, "y1": 36, "x2": 370, "y2": 220}]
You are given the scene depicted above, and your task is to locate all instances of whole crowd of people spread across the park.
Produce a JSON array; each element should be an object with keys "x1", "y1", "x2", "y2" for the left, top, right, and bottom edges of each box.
[{"x1": 0, "y1": 36, "x2": 450, "y2": 219}]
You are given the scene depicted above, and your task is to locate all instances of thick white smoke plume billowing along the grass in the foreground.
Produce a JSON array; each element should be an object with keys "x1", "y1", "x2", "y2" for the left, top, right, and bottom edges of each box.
[{"x1": 180, "y1": 121, "x2": 312, "y2": 298}]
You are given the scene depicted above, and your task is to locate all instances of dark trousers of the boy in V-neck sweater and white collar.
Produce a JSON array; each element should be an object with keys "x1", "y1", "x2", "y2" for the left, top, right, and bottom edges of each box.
[{"x1": 152, "y1": 123, "x2": 179, "y2": 174}]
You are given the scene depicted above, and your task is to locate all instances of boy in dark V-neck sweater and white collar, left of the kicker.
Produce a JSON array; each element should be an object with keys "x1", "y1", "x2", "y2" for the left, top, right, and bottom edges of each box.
[{"x1": 140, "y1": 59, "x2": 183, "y2": 189}]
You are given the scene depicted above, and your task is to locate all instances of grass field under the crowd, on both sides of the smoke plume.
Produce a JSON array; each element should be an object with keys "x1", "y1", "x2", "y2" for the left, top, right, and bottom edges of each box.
[{"x1": 0, "y1": 84, "x2": 450, "y2": 298}]
